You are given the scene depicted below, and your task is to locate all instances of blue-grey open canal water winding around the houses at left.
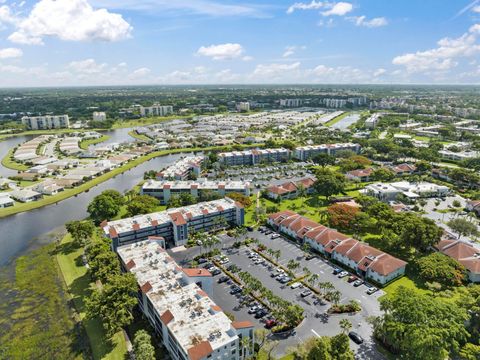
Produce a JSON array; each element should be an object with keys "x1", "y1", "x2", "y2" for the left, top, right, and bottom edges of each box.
[{"x1": 0, "y1": 129, "x2": 186, "y2": 266}]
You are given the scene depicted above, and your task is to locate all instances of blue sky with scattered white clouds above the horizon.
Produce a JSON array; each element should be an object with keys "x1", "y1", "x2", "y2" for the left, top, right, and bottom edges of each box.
[{"x1": 0, "y1": 0, "x2": 480, "y2": 87}]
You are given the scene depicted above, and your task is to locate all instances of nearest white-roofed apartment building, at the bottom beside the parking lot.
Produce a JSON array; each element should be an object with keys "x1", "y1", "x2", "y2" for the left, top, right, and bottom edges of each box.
[{"x1": 117, "y1": 238, "x2": 254, "y2": 360}]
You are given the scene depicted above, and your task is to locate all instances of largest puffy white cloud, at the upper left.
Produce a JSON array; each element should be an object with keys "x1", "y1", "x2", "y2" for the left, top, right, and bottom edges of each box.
[{"x1": 8, "y1": 0, "x2": 132, "y2": 45}]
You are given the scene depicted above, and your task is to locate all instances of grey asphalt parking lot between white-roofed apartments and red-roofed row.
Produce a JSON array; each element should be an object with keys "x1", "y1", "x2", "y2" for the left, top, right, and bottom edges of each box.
[{"x1": 169, "y1": 231, "x2": 383, "y2": 359}]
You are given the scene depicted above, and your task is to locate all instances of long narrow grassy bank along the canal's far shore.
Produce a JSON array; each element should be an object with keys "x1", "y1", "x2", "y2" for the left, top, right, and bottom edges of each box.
[{"x1": 0, "y1": 144, "x2": 261, "y2": 218}]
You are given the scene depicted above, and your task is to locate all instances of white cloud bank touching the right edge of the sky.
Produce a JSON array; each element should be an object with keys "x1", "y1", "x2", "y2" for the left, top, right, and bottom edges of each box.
[{"x1": 392, "y1": 24, "x2": 480, "y2": 73}]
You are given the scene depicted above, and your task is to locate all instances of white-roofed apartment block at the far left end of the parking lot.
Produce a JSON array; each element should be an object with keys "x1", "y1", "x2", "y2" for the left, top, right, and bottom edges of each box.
[{"x1": 101, "y1": 198, "x2": 245, "y2": 249}]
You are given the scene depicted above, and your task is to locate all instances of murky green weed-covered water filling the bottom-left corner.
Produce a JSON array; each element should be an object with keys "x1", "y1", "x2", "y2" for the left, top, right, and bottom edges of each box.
[{"x1": 0, "y1": 244, "x2": 91, "y2": 360}]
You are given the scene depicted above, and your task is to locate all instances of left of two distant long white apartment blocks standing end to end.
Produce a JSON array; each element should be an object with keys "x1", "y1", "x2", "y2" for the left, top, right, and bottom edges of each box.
[{"x1": 218, "y1": 148, "x2": 290, "y2": 166}]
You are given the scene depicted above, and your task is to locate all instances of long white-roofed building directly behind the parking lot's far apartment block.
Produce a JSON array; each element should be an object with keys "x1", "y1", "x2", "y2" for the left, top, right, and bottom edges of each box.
[{"x1": 141, "y1": 178, "x2": 250, "y2": 204}]
